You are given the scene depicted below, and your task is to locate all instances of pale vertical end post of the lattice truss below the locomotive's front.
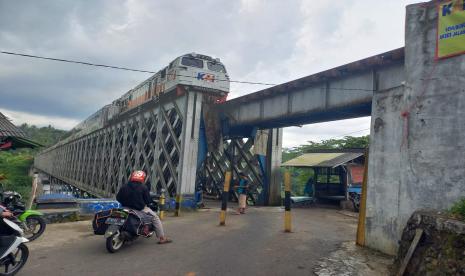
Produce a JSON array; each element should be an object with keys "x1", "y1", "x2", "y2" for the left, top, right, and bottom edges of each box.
[{"x1": 176, "y1": 91, "x2": 202, "y2": 196}]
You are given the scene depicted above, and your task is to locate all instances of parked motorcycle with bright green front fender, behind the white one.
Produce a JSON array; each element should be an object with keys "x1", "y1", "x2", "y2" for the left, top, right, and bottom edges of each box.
[{"x1": 0, "y1": 190, "x2": 47, "y2": 241}]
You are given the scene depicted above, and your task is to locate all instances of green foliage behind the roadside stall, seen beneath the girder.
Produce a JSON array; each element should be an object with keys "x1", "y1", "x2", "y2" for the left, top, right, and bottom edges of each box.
[{"x1": 282, "y1": 135, "x2": 370, "y2": 196}]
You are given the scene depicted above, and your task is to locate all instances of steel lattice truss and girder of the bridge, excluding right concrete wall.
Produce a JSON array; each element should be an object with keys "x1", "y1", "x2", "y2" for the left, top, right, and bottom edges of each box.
[{"x1": 35, "y1": 48, "x2": 405, "y2": 205}]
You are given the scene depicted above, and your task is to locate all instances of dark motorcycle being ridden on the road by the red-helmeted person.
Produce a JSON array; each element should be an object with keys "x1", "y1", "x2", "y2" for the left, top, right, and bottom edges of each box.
[{"x1": 92, "y1": 193, "x2": 158, "y2": 253}]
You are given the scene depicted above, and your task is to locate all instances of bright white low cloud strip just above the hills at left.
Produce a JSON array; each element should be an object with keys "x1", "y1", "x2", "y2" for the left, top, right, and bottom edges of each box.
[{"x1": 0, "y1": 109, "x2": 79, "y2": 130}]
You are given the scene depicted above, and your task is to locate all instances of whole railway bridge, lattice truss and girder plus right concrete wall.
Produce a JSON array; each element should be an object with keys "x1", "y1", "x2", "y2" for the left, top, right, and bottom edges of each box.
[{"x1": 31, "y1": 1, "x2": 465, "y2": 254}]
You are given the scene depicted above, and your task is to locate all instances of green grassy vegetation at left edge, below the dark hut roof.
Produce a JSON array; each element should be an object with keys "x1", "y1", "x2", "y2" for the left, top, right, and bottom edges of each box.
[{"x1": 0, "y1": 151, "x2": 33, "y2": 202}]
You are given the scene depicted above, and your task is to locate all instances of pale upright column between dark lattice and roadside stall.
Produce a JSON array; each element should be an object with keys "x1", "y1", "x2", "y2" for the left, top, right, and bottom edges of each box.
[{"x1": 265, "y1": 128, "x2": 283, "y2": 206}]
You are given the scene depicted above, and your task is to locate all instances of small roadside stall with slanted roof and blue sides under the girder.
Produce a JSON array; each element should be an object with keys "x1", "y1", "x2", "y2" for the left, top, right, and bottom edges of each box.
[{"x1": 281, "y1": 149, "x2": 365, "y2": 210}]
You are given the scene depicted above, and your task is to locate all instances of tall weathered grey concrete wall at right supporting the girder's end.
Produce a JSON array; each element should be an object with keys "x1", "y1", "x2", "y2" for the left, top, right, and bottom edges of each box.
[{"x1": 366, "y1": 2, "x2": 465, "y2": 254}]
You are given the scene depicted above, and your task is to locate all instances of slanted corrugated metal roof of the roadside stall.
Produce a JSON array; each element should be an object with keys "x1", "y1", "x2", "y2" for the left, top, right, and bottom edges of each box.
[{"x1": 281, "y1": 152, "x2": 363, "y2": 168}]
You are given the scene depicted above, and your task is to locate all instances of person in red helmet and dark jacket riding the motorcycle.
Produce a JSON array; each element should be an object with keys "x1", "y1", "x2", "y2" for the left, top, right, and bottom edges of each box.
[{"x1": 116, "y1": 171, "x2": 171, "y2": 244}]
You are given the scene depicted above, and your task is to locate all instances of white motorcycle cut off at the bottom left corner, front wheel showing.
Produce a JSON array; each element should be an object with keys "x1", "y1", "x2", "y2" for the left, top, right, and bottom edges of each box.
[{"x1": 0, "y1": 218, "x2": 29, "y2": 276}]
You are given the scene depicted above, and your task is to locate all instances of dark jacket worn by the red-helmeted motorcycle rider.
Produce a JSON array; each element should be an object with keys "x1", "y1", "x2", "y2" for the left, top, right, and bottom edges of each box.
[{"x1": 116, "y1": 182, "x2": 152, "y2": 211}]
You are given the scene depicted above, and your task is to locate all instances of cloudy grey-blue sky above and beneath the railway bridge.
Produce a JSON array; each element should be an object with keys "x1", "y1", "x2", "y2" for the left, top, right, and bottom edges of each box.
[{"x1": 0, "y1": 0, "x2": 419, "y2": 147}]
